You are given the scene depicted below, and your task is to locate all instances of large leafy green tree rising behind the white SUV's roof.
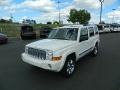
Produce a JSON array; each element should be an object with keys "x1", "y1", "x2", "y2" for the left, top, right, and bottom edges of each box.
[{"x1": 68, "y1": 9, "x2": 91, "y2": 24}]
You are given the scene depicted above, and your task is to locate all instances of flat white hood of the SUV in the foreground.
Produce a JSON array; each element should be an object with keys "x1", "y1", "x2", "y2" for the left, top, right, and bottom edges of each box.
[{"x1": 26, "y1": 39, "x2": 76, "y2": 51}]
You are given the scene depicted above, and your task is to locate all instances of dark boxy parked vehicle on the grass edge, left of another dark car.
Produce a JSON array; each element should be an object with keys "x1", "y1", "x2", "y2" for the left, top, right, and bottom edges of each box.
[{"x1": 20, "y1": 25, "x2": 36, "y2": 40}]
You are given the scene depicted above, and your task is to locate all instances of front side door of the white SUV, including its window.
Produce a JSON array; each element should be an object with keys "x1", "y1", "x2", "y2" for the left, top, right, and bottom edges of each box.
[{"x1": 78, "y1": 27, "x2": 90, "y2": 58}]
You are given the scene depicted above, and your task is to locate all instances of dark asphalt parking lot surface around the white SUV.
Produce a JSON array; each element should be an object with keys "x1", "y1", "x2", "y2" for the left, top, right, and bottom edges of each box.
[{"x1": 0, "y1": 33, "x2": 120, "y2": 90}]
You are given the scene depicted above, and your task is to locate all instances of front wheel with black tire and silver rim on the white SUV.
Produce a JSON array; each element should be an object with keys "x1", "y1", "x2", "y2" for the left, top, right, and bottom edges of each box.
[{"x1": 61, "y1": 56, "x2": 76, "y2": 77}]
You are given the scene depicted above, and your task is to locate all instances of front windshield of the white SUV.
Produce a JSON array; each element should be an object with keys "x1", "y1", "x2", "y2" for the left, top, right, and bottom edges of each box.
[{"x1": 48, "y1": 28, "x2": 78, "y2": 40}]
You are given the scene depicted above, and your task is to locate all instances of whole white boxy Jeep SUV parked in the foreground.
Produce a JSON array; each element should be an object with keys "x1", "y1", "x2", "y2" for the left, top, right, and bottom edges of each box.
[{"x1": 22, "y1": 25, "x2": 100, "y2": 76}]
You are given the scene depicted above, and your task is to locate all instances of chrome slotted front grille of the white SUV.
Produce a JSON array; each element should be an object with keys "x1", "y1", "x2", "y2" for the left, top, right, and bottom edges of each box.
[{"x1": 28, "y1": 47, "x2": 46, "y2": 60}]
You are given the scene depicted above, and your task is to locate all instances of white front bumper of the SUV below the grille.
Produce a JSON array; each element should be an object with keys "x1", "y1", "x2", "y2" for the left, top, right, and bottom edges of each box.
[{"x1": 22, "y1": 53, "x2": 62, "y2": 72}]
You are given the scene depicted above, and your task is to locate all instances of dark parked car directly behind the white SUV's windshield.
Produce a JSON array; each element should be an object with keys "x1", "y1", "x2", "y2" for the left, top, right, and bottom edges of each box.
[{"x1": 40, "y1": 26, "x2": 52, "y2": 38}]
